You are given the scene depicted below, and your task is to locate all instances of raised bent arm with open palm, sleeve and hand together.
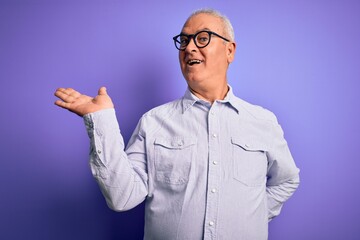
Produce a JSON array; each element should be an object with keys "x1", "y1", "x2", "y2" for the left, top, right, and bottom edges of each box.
[{"x1": 55, "y1": 87, "x2": 147, "y2": 211}]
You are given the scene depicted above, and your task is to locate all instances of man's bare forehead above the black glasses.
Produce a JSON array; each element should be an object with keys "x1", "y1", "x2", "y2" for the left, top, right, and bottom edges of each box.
[{"x1": 181, "y1": 13, "x2": 223, "y2": 34}]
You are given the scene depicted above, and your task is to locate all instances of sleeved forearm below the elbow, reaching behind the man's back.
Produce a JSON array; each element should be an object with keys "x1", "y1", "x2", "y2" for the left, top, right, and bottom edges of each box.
[{"x1": 266, "y1": 175, "x2": 300, "y2": 221}]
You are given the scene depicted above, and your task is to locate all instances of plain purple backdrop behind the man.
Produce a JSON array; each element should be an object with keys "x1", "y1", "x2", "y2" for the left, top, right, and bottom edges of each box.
[{"x1": 0, "y1": 0, "x2": 360, "y2": 240}]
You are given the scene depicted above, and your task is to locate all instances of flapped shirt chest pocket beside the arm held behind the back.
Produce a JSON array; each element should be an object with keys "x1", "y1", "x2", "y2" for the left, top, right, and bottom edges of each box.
[{"x1": 231, "y1": 138, "x2": 267, "y2": 187}]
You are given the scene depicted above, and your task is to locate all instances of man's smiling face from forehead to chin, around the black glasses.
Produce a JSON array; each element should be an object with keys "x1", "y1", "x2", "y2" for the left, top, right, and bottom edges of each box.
[{"x1": 179, "y1": 14, "x2": 235, "y2": 87}]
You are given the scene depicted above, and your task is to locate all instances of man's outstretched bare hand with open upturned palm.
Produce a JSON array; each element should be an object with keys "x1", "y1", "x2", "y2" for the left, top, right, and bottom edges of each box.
[{"x1": 55, "y1": 87, "x2": 114, "y2": 117}]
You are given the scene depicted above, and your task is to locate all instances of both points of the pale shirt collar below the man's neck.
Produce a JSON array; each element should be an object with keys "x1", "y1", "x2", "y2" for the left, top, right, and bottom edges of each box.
[{"x1": 182, "y1": 85, "x2": 240, "y2": 113}]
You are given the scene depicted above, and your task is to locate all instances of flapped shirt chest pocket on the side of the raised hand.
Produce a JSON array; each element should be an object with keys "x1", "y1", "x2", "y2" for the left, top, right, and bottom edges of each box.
[{"x1": 154, "y1": 137, "x2": 196, "y2": 184}]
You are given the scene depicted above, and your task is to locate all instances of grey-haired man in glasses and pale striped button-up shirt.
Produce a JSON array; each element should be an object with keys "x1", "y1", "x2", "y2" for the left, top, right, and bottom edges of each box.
[{"x1": 55, "y1": 10, "x2": 299, "y2": 240}]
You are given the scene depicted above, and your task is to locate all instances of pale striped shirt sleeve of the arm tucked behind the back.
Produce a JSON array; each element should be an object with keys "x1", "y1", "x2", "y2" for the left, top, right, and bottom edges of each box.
[{"x1": 266, "y1": 124, "x2": 300, "y2": 221}]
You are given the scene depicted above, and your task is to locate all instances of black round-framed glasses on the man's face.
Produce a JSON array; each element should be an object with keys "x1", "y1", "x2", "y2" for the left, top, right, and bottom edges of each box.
[{"x1": 173, "y1": 31, "x2": 230, "y2": 51}]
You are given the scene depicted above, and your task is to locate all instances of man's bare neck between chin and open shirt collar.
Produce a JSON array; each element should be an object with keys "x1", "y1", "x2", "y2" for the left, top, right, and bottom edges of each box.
[{"x1": 189, "y1": 83, "x2": 229, "y2": 104}]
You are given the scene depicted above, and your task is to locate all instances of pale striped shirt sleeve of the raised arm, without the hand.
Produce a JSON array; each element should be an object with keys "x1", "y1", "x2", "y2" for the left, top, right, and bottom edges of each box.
[{"x1": 83, "y1": 109, "x2": 148, "y2": 211}]
